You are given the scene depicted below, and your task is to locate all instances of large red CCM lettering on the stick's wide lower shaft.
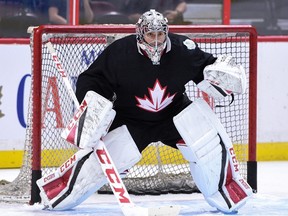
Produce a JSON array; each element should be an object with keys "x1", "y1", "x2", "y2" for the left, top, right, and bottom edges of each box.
[{"x1": 96, "y1": 149, "x2": 131, "y2": 203}]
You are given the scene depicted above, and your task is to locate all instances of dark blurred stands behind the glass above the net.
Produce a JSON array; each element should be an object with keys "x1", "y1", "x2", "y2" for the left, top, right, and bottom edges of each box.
[{"x1": 0, "y1": 0, "x2": 288, "y2": 38}]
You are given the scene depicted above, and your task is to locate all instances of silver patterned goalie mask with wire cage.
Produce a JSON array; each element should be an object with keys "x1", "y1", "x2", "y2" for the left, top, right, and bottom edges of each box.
[{"x1": 136, "y1": 9, "x2": 168, "y2": 65}]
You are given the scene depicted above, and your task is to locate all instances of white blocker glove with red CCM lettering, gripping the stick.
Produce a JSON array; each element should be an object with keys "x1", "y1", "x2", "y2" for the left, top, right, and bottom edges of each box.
[{"x1": 61, "y1": 91, "x2": 116, "y2": 148}]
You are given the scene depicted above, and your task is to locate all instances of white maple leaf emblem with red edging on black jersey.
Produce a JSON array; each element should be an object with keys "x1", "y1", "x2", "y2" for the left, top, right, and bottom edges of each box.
[{"x1": 135, "y1": 79, "x2": 176, "y2": 112}]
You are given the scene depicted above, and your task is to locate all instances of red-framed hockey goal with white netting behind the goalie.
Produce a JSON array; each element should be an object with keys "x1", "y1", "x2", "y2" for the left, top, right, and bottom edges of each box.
[{"x1": 0, "y1": 25, "x2": 257, "y2": 204}]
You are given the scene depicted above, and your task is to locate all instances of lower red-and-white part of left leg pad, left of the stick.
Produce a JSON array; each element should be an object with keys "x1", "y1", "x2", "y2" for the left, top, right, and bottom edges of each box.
[{"x1": 37, "y1": 149, "x2": 105, "y2": 210}]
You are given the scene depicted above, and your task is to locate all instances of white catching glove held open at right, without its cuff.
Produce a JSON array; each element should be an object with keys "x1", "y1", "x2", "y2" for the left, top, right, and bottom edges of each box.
[{"x1": 203, "y1": 55, "x2": 247, "y2": 94}]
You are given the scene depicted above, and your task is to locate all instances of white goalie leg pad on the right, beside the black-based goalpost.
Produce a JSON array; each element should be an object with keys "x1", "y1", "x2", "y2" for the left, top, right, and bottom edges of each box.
[{"x1": 174, "y1": 99, "x2": 252, "y2": 213}]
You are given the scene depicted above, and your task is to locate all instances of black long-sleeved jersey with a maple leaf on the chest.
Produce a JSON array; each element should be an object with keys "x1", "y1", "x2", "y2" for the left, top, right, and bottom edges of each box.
[{"x1": 76, "y1": 33, "x2": 215, "y2": 123}]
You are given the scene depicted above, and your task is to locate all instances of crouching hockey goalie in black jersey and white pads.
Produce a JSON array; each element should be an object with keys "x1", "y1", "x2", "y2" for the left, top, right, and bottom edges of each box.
[{"x1": 37, "y1": 9, "x2": 252, "y2": 215}]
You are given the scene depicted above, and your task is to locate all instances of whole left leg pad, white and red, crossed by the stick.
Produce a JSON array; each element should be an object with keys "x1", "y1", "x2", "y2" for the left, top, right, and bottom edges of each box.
[{"x1": 37, "y1": 126, "x2": 141, "y2": 210}]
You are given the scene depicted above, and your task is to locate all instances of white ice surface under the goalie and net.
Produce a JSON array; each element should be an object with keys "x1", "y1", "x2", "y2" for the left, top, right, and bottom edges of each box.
[{"x1": 0, "y1": 162, "x2": 288, "y2": 216}]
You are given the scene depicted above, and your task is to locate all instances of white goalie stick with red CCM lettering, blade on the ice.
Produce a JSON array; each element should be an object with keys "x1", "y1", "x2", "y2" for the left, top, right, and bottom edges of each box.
[{"x1": 46, "y1": 42, "x2": 180, "y2": 216}]
